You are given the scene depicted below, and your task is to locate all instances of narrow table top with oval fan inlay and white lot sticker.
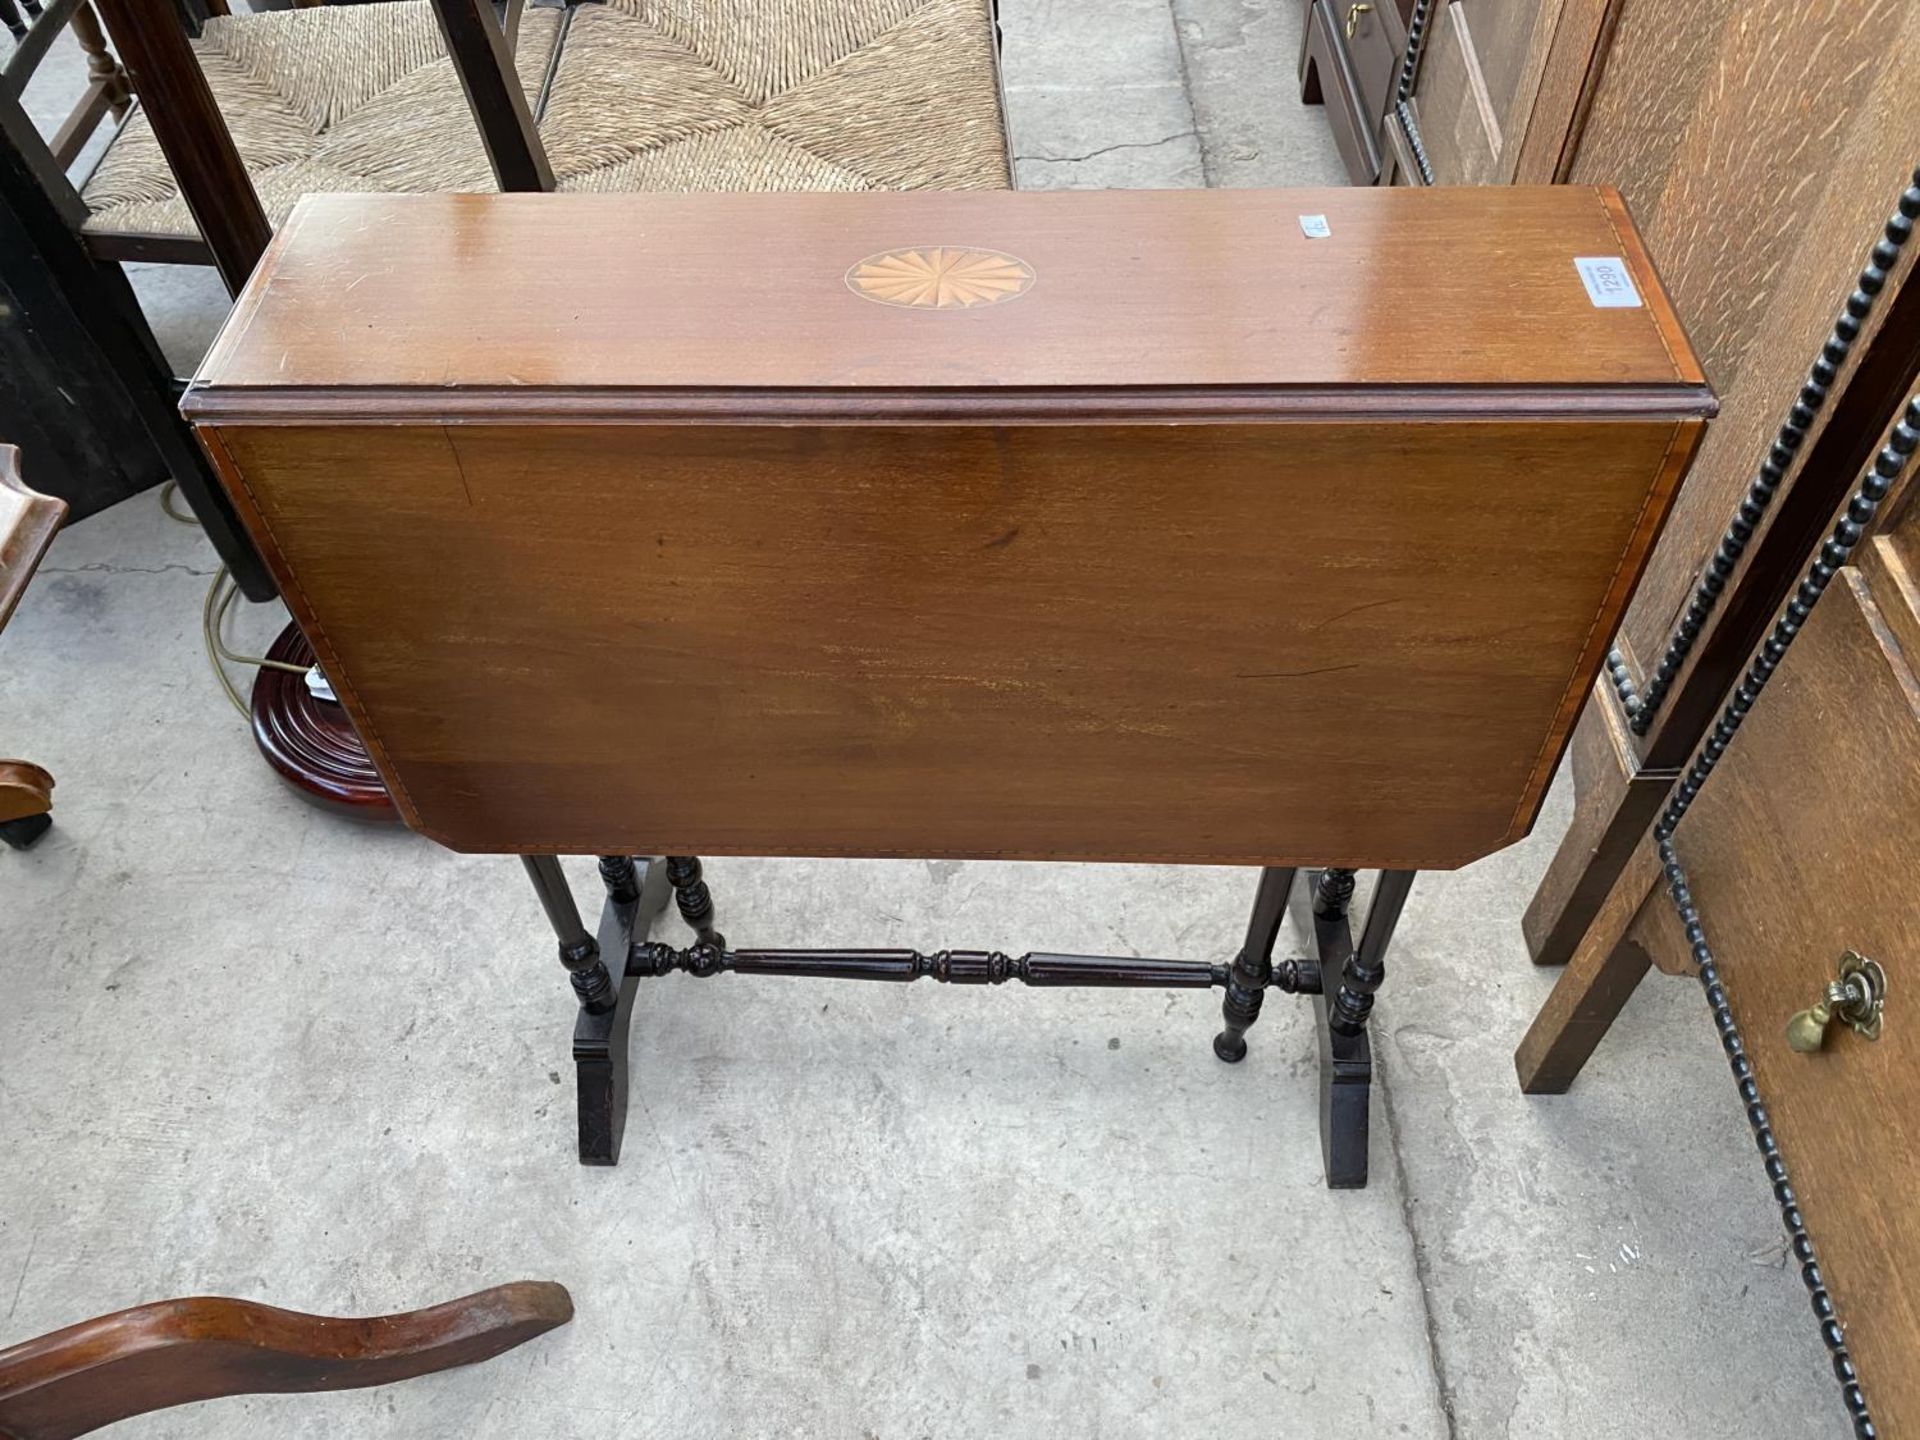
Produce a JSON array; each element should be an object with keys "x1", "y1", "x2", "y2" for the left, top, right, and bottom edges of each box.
[{"x1": 186, "y1": 186, "x2": 1711, "y2": 419}]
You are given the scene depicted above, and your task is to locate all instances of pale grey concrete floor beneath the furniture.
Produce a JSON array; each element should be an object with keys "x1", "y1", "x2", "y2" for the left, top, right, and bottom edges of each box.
[{"x1": 0, "y1": 0, "x2": 1841, "y2": 1440}]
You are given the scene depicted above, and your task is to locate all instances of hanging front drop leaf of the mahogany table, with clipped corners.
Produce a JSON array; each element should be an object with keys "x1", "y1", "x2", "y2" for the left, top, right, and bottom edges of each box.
[{"x1": 198, "y1": 420, "x2": 1697, "y2": 868}]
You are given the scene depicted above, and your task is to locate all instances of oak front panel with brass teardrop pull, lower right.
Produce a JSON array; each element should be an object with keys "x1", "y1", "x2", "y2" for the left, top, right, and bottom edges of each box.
[{"x1": 1630, "y1": 566, "x2": 1920, "y2": 1436}]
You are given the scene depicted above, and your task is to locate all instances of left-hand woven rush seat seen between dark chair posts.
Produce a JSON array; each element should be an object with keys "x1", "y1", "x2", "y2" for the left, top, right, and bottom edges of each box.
[{"x1": 81, "y1": 0, "x2": 563, "y2": 238}]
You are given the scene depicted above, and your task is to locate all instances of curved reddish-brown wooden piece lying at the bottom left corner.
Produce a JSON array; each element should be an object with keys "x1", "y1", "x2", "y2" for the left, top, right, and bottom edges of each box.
[{"x1": 0, "y1": 1281, "x2": 574, "y2": 1440}]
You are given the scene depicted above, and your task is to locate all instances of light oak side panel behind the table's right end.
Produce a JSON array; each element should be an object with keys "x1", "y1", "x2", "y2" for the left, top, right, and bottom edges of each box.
[{"x1": 1572, "y1": 0, "x2": 1920, "y2": 662}]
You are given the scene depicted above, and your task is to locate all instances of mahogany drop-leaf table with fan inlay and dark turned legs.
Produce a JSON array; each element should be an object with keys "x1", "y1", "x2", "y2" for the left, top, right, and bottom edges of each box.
[{"x1": 184, "y1": 186, "x2": 1713, "y2": 1185}]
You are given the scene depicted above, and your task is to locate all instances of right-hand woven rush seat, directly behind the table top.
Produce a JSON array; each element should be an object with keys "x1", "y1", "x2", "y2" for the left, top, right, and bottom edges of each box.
[{"x1": 540, "y1": 0, "x2": 1010, "y2": 190}]
